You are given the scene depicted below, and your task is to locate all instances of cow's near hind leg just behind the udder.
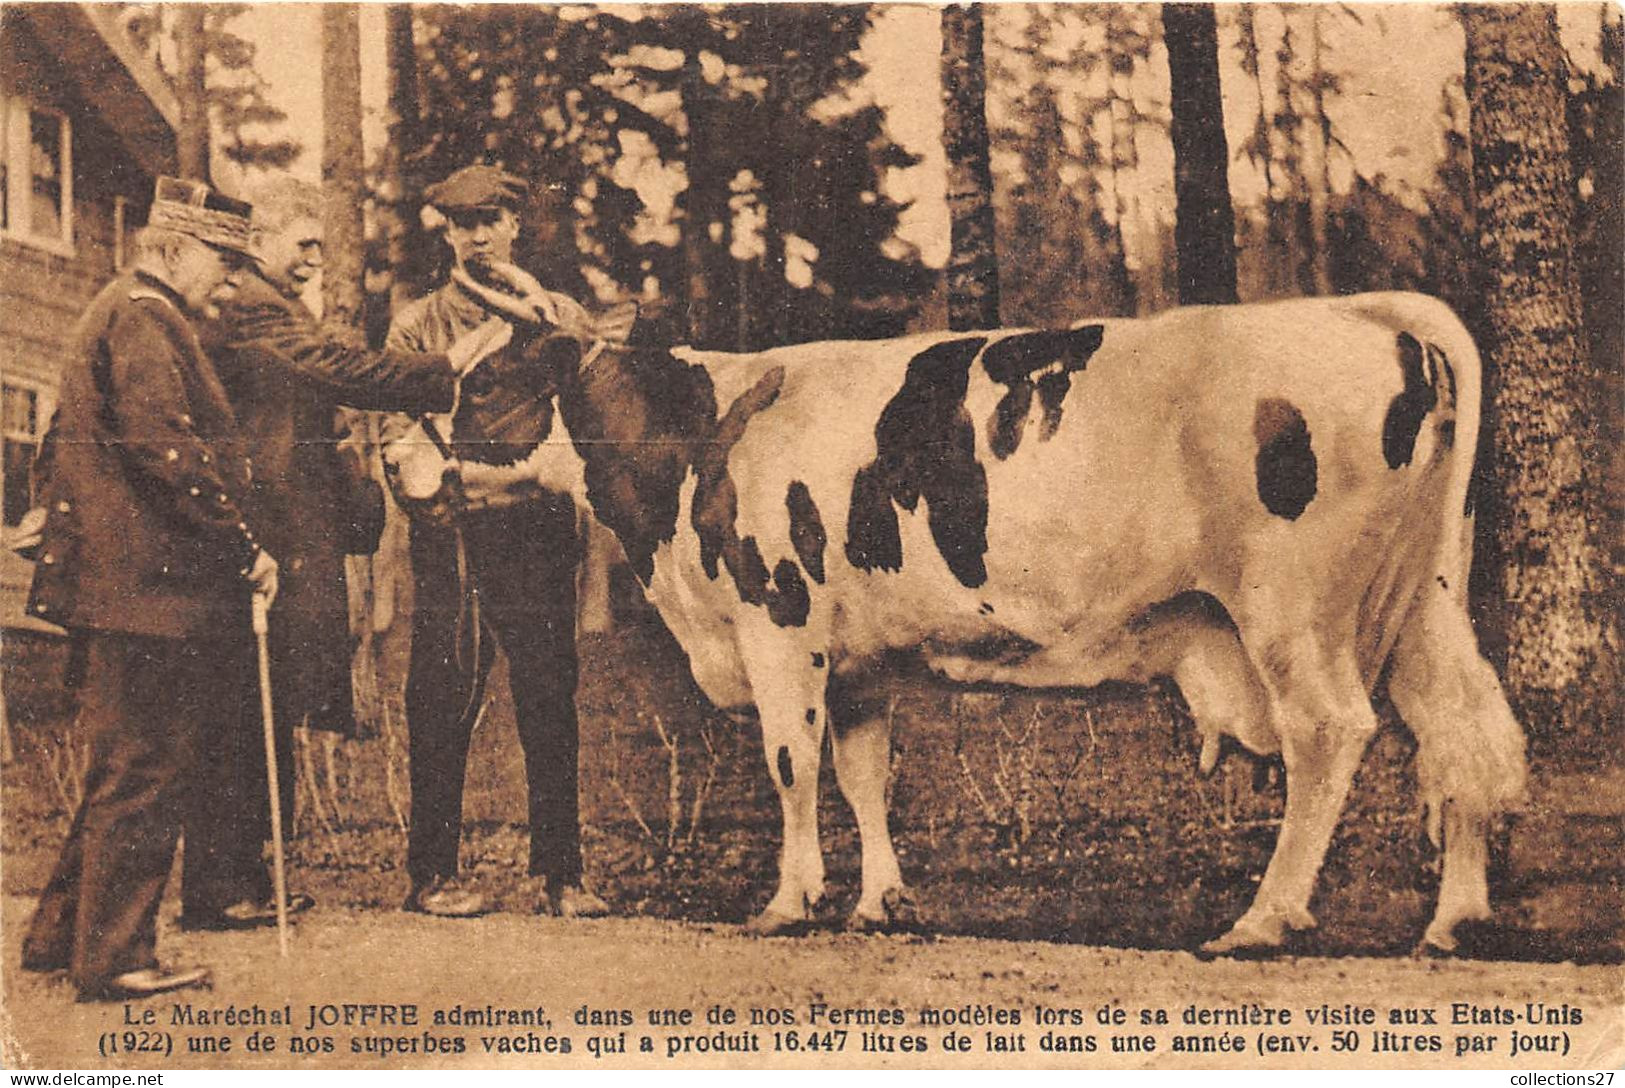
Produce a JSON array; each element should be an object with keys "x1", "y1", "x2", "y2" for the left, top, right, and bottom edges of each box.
[{"x1": 1203, "y1": 648, "x2": 1376, "y2": 955}]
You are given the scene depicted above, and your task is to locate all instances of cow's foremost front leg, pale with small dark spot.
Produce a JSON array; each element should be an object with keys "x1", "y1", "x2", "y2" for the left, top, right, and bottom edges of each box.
[{"x1": 739, "y1": 625, "x2": 826, "y2": 934}]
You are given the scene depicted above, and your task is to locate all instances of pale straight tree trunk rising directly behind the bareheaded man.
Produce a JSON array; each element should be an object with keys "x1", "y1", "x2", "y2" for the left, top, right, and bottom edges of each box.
[{"x1": 322, "y1": 3, "x2": 367, "y2": 323}]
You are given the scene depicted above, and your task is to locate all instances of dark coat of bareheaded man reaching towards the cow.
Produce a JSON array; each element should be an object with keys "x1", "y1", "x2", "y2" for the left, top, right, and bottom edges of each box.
[{"x1": 203, "y1": 274, "x2": 457, "y2": 731}]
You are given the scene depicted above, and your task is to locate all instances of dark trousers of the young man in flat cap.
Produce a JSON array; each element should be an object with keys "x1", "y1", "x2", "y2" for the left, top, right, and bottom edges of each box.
[{"x1": 406, "y1": 495, "x2": 582, "y2": 887}]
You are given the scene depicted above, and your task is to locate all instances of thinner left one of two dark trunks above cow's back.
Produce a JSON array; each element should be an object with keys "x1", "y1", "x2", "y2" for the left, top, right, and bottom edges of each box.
[{"x1": 943, "y1": 3, "x2": 999, "y2": 330}]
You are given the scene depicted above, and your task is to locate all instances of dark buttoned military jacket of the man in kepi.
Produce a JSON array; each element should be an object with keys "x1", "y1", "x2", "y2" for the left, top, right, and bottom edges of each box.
[{"x1": 28, "y1": 274, "x2": 258, "y2": 638}]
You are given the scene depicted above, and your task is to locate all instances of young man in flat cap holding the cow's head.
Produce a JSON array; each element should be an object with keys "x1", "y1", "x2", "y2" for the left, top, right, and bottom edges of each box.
[{"x1": 385, "y1": 166, "x2": 608, "y2": 917}]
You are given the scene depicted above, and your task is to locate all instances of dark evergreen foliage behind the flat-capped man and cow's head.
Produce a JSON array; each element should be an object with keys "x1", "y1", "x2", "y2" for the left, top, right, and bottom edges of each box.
[{"x1": 408, "y1": 5, "x2": 931, "y2": 349}]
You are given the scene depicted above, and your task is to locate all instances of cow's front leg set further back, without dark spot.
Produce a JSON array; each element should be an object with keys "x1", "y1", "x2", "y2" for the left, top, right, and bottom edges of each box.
[{"x1": 830, "y1": 698, "x2": 915, "y2": 929}]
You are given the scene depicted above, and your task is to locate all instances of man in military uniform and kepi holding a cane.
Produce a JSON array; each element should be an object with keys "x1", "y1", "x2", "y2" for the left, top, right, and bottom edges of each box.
[{"x1": 23, "y1": 179, "x2": 278, "y2": 999}]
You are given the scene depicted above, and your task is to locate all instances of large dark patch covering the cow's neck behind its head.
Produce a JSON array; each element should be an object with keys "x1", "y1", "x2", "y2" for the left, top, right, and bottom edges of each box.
[{"x1": 557, "y1": 341, "x2": 717, "y2": 586}]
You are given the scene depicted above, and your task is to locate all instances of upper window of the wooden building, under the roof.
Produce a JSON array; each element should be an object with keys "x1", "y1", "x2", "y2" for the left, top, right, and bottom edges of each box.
[{"x1": 0, "y1": 97, "x2": 73, "y2": 257}]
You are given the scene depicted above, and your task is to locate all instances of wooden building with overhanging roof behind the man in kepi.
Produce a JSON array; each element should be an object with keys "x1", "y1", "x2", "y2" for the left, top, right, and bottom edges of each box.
[{"x1": 0, "y1": 3, "x2": 179, "y2": 627}]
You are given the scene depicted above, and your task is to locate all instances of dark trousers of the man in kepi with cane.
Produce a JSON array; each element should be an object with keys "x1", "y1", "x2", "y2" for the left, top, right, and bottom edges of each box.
[{"x1": 23, "y1": 632, "x2": 242, "y2": 991}]
